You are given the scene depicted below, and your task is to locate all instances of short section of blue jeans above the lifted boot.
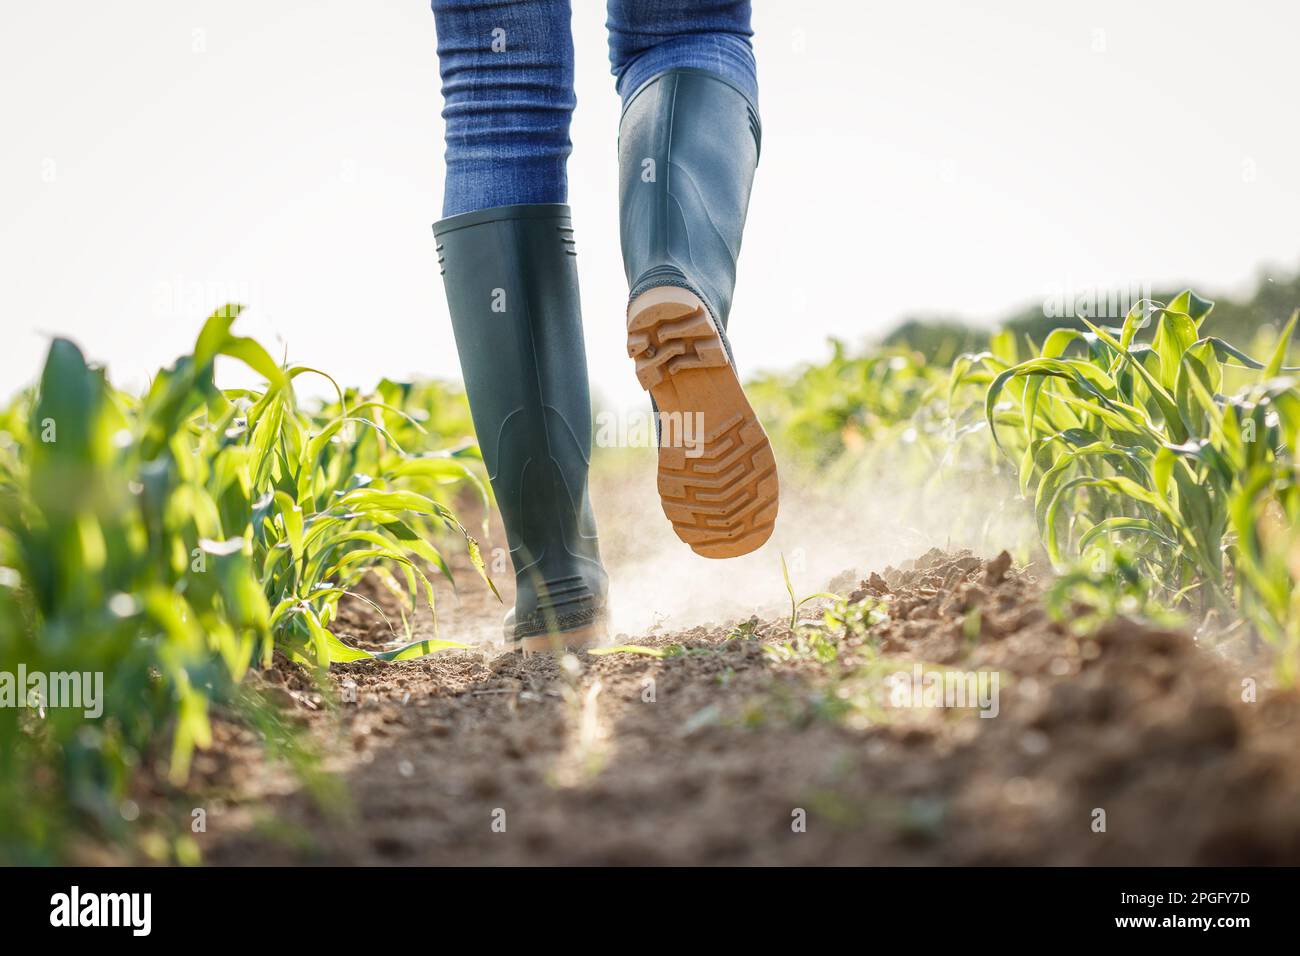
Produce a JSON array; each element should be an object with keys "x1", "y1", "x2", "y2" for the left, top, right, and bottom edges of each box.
[{"x1": 606, "y1": 0, "x2": 758, "y2": 105}]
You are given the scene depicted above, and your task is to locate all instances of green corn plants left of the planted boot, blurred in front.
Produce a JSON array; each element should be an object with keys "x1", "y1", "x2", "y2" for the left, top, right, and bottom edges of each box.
[{"x1": 0, "y1": 307, "x2": 490, "y2": 858}]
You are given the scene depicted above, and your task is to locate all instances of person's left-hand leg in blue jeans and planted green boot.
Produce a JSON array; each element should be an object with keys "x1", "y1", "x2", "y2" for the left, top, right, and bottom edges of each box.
[{"x1": 433, "y1": 0, "x2": 607, "y2": 650}]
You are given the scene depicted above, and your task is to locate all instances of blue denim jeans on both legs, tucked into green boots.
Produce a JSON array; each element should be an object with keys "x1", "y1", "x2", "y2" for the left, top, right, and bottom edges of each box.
[{"x1": 433, "y1": 0, "x2": 758, "y2": 217}]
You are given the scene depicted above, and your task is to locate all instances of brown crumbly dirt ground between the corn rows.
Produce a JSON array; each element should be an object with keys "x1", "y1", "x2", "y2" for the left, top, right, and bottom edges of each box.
[{"x1": 188, "y1": 541, "x2": 1300, "y2": 865}]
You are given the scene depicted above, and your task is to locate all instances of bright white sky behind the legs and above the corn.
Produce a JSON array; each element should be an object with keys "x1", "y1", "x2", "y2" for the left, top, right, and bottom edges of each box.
[{"x1": 0, "y1": 0, "x2": 1300, "y2": 405}]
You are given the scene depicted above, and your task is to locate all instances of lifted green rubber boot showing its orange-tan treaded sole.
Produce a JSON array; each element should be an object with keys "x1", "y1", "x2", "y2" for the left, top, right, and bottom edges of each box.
[{"x1": 619, "y1": 69, "x2": 779, "y2": 558}]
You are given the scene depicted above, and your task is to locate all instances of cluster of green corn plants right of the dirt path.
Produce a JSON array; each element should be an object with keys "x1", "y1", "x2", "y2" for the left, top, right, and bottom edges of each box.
[{"x1": 953, "y1": 291, "x2": 1300, "y2": 679}]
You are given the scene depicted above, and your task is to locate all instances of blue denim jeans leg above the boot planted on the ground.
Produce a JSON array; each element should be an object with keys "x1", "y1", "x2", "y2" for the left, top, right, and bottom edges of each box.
[{"x1": 433, "y1": 0, "x2": 576, "y2": 216}]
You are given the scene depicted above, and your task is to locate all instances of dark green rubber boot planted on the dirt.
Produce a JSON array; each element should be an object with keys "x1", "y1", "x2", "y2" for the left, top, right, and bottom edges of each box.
[{"x1": 433, "y1": 203, "x2": 608, "y2": 652}]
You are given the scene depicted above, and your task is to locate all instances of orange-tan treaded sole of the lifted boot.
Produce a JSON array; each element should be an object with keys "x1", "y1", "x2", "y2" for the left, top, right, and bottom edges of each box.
[{"x1": 628, "y1": 286, "x2": 780, "y2": 558}]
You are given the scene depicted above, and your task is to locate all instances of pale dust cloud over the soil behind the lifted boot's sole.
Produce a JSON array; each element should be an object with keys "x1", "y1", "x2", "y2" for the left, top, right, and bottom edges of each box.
[{"x1": 592, "y1": 449, "x2": 1035, "y2": 639}]
